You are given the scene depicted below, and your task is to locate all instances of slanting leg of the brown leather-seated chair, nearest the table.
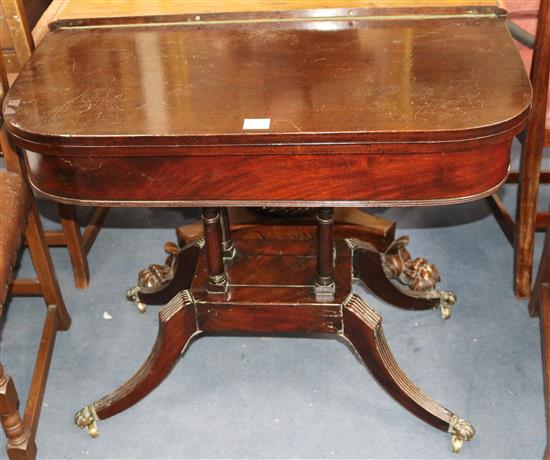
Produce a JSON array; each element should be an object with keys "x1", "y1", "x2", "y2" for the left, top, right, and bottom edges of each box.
[{"x1": 25, "y1": 201, "x2": 71, "y2": 330}]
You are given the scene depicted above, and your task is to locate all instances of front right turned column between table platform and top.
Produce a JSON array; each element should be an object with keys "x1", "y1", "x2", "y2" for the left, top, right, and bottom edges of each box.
[{"x1": 315, "y1": 208, "x2": 336, "y2": 299}]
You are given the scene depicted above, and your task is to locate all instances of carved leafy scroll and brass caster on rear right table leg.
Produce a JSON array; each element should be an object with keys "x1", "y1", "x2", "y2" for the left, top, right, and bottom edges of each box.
[{"x1": 382, "y1": 236, "x2": 456, "y2": 319}]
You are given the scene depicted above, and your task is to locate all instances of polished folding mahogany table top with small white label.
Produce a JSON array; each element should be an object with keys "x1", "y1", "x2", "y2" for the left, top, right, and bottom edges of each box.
[{"x1": 4, "y1": 1, "x2": 531, "y2": 154}]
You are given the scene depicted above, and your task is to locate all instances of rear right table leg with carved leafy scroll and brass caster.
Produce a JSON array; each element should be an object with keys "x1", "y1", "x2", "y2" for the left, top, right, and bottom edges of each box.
[{"x1": 347, "y1": 237, "x2": 456, "y2": 319}]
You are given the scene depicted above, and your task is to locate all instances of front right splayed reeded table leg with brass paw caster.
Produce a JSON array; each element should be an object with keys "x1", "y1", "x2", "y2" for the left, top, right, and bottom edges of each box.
[{"x1": 342, "y1": 294, "x2": 475, "y2": 452}]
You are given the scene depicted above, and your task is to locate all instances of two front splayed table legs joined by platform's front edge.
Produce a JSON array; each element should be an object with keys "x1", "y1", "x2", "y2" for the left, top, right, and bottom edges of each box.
[{"x1": 75, "y1": 291, "x2": 475, "y2": 452}]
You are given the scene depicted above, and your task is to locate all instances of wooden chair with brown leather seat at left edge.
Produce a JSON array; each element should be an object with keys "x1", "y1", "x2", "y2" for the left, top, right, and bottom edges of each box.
[{"x1": 0, "y1": 49, "x2": 71, "y2": 460}]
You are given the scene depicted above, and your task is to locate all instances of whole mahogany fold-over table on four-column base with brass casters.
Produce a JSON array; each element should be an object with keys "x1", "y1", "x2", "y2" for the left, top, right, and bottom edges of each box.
[{"x1": 3, "y1": 7, "x2": 531, "y2": 451}]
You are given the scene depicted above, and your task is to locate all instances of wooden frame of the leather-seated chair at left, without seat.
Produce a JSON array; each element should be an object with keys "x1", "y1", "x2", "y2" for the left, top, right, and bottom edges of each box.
[{"x1": 0, "y1": 50, "x2": 71, "y2": 460}]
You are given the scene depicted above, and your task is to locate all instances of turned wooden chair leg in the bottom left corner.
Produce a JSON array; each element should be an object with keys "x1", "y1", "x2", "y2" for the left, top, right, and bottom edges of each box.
[{"x1": 0, "y1": 364, "x2": 36, "y2": 460}]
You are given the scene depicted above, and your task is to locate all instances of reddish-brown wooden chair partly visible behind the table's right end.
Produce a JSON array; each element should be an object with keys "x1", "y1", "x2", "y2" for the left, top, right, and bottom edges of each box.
[{"x1": 489, "y1": 0, "x2": 550, "y2": 297}]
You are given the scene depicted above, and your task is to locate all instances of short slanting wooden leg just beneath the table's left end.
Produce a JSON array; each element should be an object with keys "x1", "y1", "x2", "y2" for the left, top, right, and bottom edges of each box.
[{"x1": 58, "y1": 204, "x2": 90, "y2": 289}]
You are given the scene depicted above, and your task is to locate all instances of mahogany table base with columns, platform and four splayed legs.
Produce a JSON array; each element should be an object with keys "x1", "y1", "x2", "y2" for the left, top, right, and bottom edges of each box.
[{"x1": 75, "y1": 208, "x2": 474, "y2": 452}]
